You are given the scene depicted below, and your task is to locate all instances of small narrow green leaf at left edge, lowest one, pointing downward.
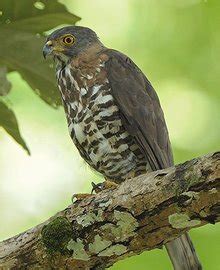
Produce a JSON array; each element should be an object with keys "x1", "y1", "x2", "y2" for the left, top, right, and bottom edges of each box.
[{"x1": 0, "y1": 101, "x2": 30, "y2": 155}]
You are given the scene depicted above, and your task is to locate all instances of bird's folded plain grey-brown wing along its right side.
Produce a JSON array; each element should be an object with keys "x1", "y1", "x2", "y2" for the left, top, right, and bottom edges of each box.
[{"x1": 106, "y1": 50, "x2": 173, "y2": 170}]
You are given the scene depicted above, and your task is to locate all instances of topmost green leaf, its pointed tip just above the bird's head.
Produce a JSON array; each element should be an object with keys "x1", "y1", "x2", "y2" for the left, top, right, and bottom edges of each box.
[{"x1": 0, "y1": 0, "x2": 80, "y2": 33}]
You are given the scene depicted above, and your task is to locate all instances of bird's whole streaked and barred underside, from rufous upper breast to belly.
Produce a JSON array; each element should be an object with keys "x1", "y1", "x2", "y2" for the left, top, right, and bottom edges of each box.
[{"x1": 57, "y1": 54, "x2": 147, "y2": 182}]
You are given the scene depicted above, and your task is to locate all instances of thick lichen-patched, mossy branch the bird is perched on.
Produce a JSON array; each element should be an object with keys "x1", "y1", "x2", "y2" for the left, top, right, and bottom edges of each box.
[{"x1": 0, "y1": 152, "x2": 220, "y2": 269}]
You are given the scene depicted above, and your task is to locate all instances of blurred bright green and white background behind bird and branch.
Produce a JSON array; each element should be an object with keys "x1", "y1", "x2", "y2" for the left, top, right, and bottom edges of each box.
[{"x1": 0, "y1": 0, "x2": 220, "y2": 270}]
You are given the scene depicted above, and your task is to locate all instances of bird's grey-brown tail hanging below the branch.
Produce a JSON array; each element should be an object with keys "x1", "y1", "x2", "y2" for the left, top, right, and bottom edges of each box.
[{"x1": 165, "y1": 233, "x2": 202, "y2": 270}]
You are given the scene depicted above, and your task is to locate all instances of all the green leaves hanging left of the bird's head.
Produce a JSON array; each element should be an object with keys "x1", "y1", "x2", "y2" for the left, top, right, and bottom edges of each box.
[{"x1": 0, "y1": 0, "x2": 79, "y2": 152}]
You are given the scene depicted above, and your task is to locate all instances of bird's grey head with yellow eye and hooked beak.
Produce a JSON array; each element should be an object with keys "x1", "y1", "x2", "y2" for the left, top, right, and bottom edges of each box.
[{"x1": 43, "y1": 26, "x2": 101, "y2": 62}]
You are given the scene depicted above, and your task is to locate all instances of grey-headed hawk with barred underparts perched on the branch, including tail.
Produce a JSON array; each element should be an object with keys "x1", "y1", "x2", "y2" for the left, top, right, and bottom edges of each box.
[{"x1": 43, "y1": 26, "x2": 201, "y2": 270}]
